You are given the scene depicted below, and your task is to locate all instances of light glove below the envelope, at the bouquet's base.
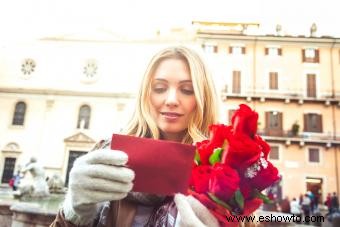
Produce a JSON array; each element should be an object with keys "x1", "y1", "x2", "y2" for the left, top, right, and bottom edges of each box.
[{"x1": 174, "y1": 194, "x2": 220, "y2": 227}]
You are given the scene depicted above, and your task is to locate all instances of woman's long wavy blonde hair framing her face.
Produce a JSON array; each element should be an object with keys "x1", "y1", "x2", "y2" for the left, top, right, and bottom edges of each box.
[{"x1": 126, "y1": 46, "x2": 218, "y2": 144}]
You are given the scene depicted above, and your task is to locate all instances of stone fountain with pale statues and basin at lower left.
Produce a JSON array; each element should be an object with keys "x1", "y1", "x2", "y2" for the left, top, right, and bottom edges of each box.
[{"x1": 0, "y1": 158, "x2": 65, "y2": 227}]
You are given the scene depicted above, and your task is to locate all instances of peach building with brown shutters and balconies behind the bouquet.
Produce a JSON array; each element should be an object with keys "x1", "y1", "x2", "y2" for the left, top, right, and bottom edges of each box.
[{"x1": 196, "y1": 22, "x2": 340, "y2": 202}]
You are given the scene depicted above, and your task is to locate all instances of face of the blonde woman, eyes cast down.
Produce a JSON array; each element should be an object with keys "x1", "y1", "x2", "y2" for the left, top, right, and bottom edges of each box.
[{"x1": 150, "y1": 59, "x2": 196, "y2": 141}]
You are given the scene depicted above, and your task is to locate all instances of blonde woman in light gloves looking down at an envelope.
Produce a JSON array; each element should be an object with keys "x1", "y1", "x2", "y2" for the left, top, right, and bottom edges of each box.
[{"x1": 51, "y1": 47, "x2": 218, "y2": 227}]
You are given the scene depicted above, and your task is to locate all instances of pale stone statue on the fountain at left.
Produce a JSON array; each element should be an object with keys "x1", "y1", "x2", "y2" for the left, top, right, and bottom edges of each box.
[{"x1": 14, "y1": 157, "x2": 49, "y2": 198}]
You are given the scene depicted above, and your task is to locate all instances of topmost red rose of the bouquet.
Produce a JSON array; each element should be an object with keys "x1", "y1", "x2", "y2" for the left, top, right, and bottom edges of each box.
[{"x1": 231, "y1": 104, "x2": 259, "y2": 138}]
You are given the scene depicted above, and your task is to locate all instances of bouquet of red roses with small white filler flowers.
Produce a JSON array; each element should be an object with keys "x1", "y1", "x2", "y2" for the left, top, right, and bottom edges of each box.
[{"x1": 189, "y1": 104, "x2": 279, "y2": 226}]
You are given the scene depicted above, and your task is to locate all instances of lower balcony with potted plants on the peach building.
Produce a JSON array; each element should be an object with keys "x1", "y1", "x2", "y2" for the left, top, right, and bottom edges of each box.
[{"x1": 257, "y1": 129, "x2": 340, "y2": 147}]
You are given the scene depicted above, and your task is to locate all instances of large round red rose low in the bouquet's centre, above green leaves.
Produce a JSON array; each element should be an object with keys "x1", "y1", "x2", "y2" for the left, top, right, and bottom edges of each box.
[{"x1": 209, "y1": 163, "x2": 240, "y2": 201}]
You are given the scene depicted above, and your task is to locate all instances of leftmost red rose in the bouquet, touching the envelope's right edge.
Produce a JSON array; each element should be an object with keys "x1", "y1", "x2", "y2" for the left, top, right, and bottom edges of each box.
[{"x1": 189, "y1": 165, "x2": 212, "y2": 193}]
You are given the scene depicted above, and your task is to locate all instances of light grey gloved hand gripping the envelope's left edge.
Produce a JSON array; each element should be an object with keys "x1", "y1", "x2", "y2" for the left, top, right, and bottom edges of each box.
[{"x1": 63, "y1": 149, "x2": 135, "y2": 225}]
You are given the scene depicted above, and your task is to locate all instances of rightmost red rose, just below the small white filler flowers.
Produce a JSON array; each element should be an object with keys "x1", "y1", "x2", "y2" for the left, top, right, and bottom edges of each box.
[{"x1": 246, "y1": 161, "x2": 280, "y2": 191}]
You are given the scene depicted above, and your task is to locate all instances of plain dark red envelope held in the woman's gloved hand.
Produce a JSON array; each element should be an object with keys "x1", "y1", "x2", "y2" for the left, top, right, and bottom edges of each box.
[{"x1": 111, "y1": 134, "x2": 196, "y2": 195}]
